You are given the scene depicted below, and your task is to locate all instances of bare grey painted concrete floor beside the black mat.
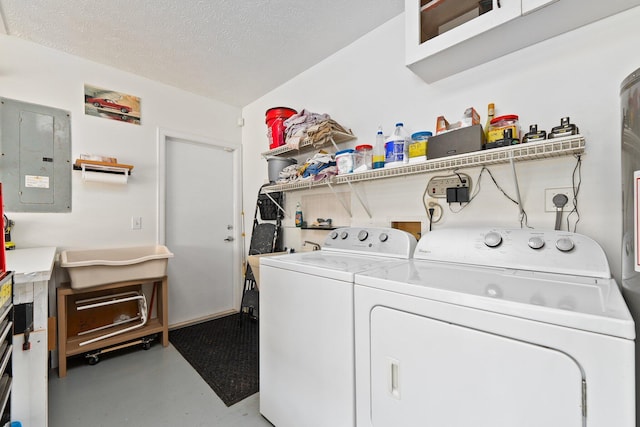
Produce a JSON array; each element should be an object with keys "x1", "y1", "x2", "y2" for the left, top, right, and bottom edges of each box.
[{"x1": 49, "y1": 343, "x2": 272, "y2": 427}]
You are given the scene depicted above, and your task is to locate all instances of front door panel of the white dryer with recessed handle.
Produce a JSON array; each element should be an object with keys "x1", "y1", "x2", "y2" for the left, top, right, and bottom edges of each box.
[{"x1": 370, "y1": 306, "x2": 583, "y2": 427}]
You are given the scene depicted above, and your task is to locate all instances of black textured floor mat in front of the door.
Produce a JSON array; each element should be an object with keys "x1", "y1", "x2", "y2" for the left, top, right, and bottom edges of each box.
[{"x1": 169, "y1": 313, "x2": 258, "y2": 406}]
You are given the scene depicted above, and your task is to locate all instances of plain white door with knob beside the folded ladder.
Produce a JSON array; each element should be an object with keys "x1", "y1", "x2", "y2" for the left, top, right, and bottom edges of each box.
[{"x1": 161, "y1": 132, "x2": 240, "y2": 326}]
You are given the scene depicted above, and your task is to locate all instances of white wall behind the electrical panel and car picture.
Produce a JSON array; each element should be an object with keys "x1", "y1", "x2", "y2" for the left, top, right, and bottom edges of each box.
[{"x1": 0, "y1": 35, "x2": 241, "y2": 249}]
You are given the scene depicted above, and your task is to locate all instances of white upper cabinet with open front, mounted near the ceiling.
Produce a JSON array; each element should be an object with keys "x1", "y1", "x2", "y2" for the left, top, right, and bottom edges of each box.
[{"x1": 405, "y1": 0, "x2": 640, "y2": 83}]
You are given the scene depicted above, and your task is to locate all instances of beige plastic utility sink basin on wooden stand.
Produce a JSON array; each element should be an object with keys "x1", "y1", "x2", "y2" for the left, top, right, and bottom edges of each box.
[{"x1": 60, "y1": 245, "x2": 173, "y2": 289}]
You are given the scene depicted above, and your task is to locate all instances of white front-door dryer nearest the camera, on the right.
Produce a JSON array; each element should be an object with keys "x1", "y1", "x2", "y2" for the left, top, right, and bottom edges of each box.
[{"x1": 354, "y1": 229, "x2": 635, "y2": 427}]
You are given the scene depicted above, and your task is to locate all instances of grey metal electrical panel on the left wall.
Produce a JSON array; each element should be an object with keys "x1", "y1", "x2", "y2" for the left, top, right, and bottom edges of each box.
[{"x1": 0, "y1": 98, "x2": 71, "y2": 212}]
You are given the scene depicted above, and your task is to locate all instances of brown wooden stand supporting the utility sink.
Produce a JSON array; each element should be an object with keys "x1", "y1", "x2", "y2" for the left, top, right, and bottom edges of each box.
[{"x1": 57, "y1": 276, "x2": 169, "y2": 378}]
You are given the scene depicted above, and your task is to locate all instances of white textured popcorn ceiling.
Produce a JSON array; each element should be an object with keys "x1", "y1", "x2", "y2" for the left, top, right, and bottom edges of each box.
[{"x1": 0, "y1": 0, "x2": 404, "y2": 106}]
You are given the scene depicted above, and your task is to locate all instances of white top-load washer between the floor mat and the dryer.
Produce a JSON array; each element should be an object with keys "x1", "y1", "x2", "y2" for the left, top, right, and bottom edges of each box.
[{"x1": 259, "y1": 228, "x2": 417, "y2": 427}]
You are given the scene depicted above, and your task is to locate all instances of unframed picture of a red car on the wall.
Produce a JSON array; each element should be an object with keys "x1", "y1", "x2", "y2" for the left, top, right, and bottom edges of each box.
[{"x1": 84, "y1": 84, "x2": 140, "y2": 125}]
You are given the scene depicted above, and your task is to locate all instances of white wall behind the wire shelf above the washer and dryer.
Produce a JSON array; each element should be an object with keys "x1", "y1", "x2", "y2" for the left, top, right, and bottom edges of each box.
[{"x1": 242, "y1": 8, "x2": 640, "y2": 277}]
